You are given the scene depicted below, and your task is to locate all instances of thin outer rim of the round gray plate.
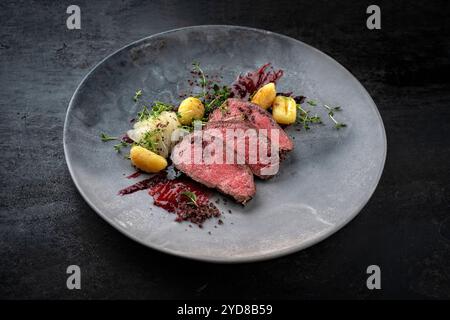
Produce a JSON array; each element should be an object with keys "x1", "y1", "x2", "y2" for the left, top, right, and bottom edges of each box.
[{"x1": 63, "y1": 24, "x2": 387, "y2": 264}]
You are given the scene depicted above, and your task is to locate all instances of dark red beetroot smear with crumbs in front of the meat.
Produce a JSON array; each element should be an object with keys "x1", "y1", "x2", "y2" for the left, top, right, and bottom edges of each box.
[{"x1": 119, "y1": 174, "x2": 220, "y2": 227}]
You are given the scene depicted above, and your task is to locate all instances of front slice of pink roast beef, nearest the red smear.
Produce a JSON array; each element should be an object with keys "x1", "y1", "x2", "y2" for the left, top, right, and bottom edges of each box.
[{"x1": 171, "y1": 130, "x2": 256, "y2": 203}]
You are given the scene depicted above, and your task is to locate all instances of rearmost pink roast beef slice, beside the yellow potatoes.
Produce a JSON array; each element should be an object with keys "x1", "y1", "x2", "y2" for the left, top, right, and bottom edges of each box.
[{"x1": 209, "y1": 98, "x2": 294, "y2": 154}]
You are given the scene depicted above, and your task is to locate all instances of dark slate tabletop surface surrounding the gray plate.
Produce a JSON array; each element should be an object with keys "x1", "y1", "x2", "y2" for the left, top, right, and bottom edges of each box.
[{"x1": 0, "y1": 0, "x2": 450, "y2": 299}]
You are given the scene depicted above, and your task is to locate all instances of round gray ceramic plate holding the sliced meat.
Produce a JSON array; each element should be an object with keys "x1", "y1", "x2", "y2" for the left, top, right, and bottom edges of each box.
[{"x1": 64, "y1": 26, "x2": 386, "y2": 262}]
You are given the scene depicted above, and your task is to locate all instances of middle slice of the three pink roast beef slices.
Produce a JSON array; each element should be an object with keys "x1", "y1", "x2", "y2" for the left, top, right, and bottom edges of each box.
[{"x1": 204, "y1": 121, "x2": 280, "y2": 179}]
